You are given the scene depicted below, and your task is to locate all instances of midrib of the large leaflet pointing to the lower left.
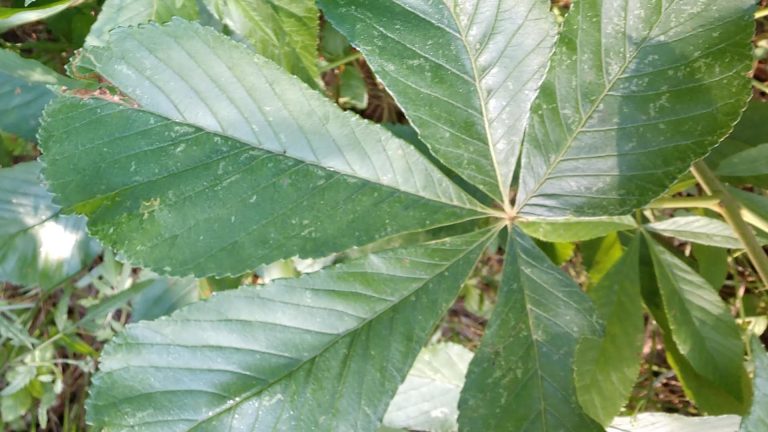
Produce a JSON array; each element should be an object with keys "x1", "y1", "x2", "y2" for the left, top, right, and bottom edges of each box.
[{"x1": 178, "y1": 225, "x2": 503, "y2": 431}]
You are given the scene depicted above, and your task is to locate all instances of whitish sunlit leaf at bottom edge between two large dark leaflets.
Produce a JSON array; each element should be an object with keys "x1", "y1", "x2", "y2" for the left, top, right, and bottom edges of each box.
[{"x1": 382, "y1": 343, "x2": 472, "y2": 432}]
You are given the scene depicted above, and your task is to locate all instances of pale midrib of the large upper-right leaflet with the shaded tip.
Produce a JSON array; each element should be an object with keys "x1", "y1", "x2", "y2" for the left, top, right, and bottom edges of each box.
[{"x1": 515, "y1": 0, "x2": 677, "y2": 213}]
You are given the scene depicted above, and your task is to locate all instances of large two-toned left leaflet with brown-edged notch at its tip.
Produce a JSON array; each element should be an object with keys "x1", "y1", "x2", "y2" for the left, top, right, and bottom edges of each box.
[{"x1": 40, "y1": 19, "x2": 484, "y2": 276}]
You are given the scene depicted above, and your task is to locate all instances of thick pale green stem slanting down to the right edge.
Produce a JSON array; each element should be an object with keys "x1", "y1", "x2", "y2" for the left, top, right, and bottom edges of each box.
[{"x1": 691, "y1": 161, "x2": 768, "y2": 285}]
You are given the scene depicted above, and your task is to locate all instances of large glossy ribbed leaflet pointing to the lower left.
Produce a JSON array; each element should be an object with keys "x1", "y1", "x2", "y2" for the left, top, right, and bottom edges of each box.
[{"x1": 88, "y1": 228, "x2": 497, "y2": 432}]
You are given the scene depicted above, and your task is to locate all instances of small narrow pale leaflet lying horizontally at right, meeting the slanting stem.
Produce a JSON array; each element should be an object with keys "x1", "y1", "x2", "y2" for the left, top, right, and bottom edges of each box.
[{"x1": 645, "y1": 216, "x2": 768, "y2": 249}]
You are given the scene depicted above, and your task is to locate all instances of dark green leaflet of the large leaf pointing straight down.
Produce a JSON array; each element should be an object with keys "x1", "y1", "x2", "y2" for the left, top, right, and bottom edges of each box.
[{"x1": 459, "y1": 228, "x2": 602, "y2": 432}]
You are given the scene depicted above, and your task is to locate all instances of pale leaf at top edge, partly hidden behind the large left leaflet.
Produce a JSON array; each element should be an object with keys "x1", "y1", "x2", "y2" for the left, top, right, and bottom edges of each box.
[{"x1": 85, "y1": 0, "x2": 199, "y2": 45}]
